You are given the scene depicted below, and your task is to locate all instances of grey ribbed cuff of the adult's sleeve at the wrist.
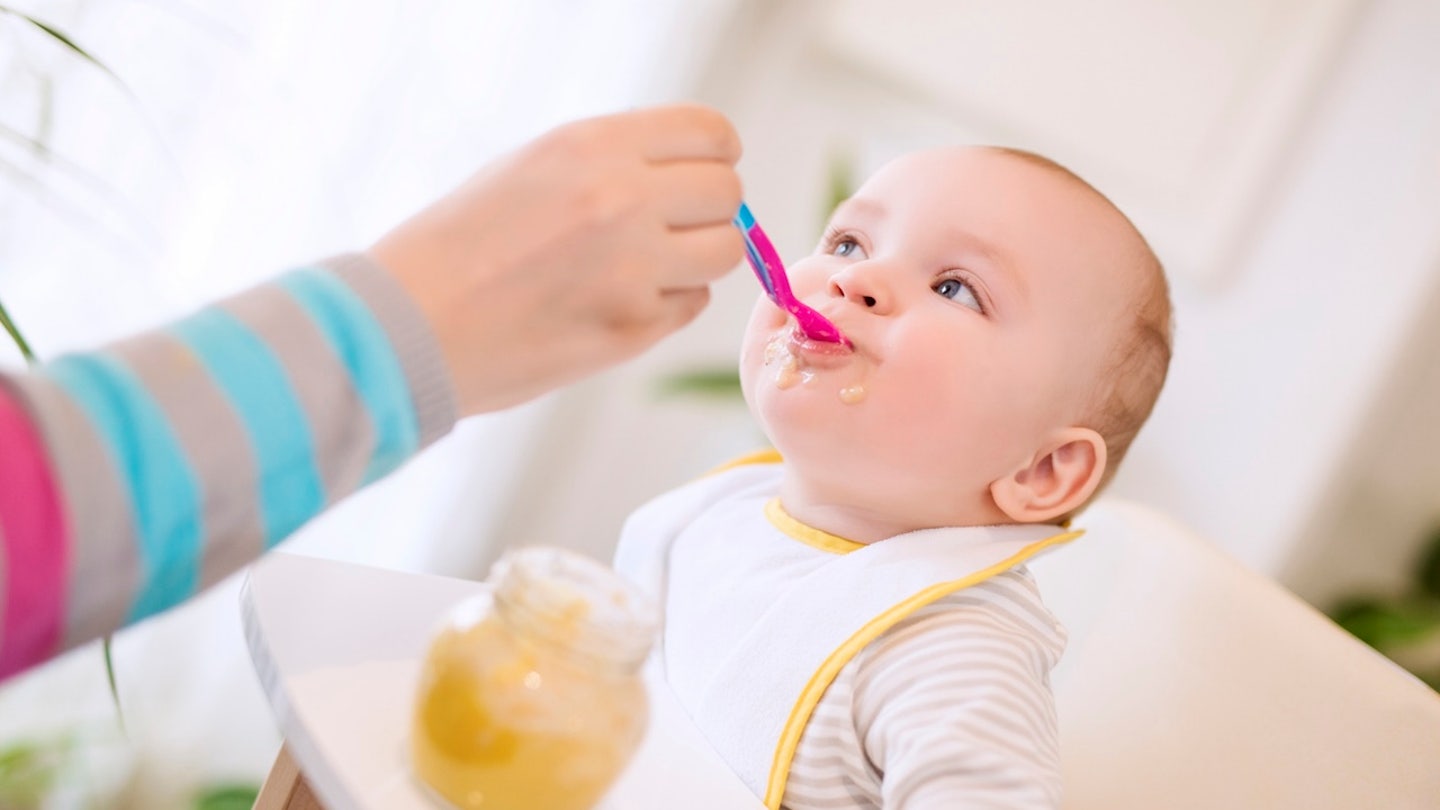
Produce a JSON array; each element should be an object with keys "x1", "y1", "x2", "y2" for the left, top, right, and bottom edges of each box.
[{"x1": 320, "y1": 254, "x2": 456, "y2": 450}]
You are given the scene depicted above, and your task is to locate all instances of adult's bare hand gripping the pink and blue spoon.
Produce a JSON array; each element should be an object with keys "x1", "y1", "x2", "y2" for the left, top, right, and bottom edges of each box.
[{"x1": 370, "y1": 105, "x2": 743, "y2": 415}]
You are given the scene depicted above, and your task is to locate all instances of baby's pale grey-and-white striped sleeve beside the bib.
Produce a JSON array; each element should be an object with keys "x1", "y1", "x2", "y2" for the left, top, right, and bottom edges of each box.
[{"x1": 783, "y1": 569, "x2": 1064, "y2": 810}]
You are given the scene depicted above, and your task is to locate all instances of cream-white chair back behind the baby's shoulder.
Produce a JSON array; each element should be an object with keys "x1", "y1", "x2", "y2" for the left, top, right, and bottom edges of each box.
[{"x1": 1031, "y1": 500, "x2": 1440, "y2": 810}]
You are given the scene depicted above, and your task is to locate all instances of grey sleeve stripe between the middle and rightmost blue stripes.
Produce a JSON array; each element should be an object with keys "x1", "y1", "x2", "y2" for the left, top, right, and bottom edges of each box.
[{"x1": 219, "y1": 285, "x2": 376, "y2": 503}]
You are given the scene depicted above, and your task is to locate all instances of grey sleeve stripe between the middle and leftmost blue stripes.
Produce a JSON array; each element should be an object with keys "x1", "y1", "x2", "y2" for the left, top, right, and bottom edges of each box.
[{"x1": 109, "y1": 331, "x2": 265, "y2": 588}]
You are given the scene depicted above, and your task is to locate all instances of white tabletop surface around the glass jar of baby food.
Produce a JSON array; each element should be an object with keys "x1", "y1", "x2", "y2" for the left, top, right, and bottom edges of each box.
[{"x1": 242, "y1": 552, "x2": 763, "y2": 810}]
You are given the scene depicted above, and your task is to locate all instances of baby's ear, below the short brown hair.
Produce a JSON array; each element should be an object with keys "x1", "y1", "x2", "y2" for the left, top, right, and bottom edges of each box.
[{"x1": 989, "y1": 428, "x2": 1106, "y2": 523}]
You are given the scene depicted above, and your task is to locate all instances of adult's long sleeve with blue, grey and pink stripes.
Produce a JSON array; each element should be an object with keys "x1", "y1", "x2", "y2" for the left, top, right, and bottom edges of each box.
[{"x1": 0, "y1": 255, "x2": 455, "y2": 677}]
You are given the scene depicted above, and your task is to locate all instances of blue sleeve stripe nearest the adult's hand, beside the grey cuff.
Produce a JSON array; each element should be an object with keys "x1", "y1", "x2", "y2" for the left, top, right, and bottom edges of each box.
[{"x1": 278, "y1": 268, "x2": 420, "y2": 483}]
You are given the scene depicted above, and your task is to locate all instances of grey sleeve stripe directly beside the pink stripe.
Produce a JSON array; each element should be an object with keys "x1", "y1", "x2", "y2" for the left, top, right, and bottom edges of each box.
[{"x1": 12, "y1": 375, "x2": 144, "y2": 650}]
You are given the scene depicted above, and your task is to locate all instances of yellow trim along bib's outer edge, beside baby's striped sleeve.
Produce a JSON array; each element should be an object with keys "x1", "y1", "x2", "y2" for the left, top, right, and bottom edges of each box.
[{"x1": 765, "y1": 530, "x2": 1084, "y2": 810}]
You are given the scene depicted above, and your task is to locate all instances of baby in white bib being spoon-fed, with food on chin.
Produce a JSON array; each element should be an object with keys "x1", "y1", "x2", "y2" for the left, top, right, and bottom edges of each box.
[{"x1": 616, "y1": 147, "x2": 1171, "y2": 810}]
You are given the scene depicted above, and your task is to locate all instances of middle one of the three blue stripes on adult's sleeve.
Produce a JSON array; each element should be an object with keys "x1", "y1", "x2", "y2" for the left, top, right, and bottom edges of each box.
[{"x1": 170, "y1": 310, "x2": 325, "y2": 548}]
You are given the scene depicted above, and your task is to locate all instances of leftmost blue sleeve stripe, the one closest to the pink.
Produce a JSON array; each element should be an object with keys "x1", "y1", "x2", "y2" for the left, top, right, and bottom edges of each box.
[{"x1": 42, "y1": 355, "x2": 204, "y2": 624}]
